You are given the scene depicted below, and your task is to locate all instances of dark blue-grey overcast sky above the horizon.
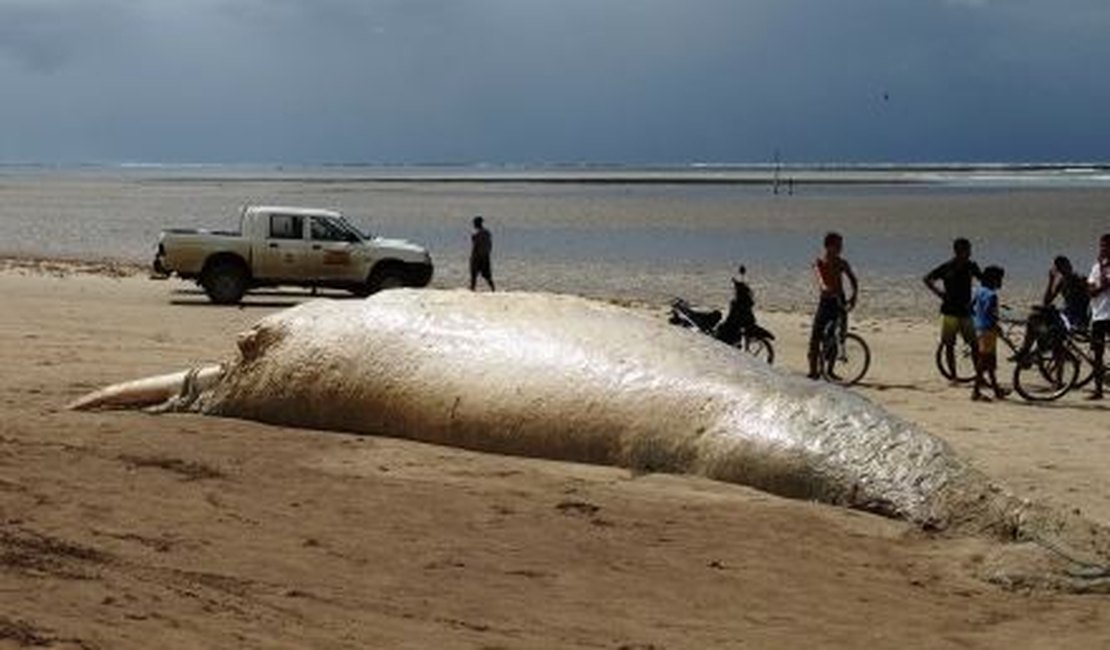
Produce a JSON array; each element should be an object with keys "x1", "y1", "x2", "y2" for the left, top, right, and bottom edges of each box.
[{"x1": 0, "y1": 0, "x2": 1110, "y2": 163}]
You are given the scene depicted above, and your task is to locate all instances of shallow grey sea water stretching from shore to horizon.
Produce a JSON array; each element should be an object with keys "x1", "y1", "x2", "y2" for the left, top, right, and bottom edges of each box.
[{"x1": 0, "y1": 165, "x2": 1110, "y2": 315}]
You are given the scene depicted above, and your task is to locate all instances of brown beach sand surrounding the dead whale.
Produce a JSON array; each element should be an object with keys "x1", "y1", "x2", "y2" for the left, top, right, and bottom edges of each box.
[{"x1": 0, "y1": 262, "x2": 1110, "y2": 650}]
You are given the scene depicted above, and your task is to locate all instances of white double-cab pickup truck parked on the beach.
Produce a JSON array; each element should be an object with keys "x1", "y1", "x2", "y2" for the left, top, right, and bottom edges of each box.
[{"x1": 154, "y1": 205, "x2": 432, "y2": 305}]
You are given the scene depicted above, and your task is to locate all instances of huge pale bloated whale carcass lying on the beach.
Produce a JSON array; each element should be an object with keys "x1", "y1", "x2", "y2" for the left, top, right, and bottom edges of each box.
[{"x1": 71, "y1": 290, "x2": 1110, "y2": 581}]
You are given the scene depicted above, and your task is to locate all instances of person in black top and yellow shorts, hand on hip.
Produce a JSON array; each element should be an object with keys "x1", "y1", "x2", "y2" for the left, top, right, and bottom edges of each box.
[{"x1": 925, "y1": 237, "x2": 982, "y2": 379}]
